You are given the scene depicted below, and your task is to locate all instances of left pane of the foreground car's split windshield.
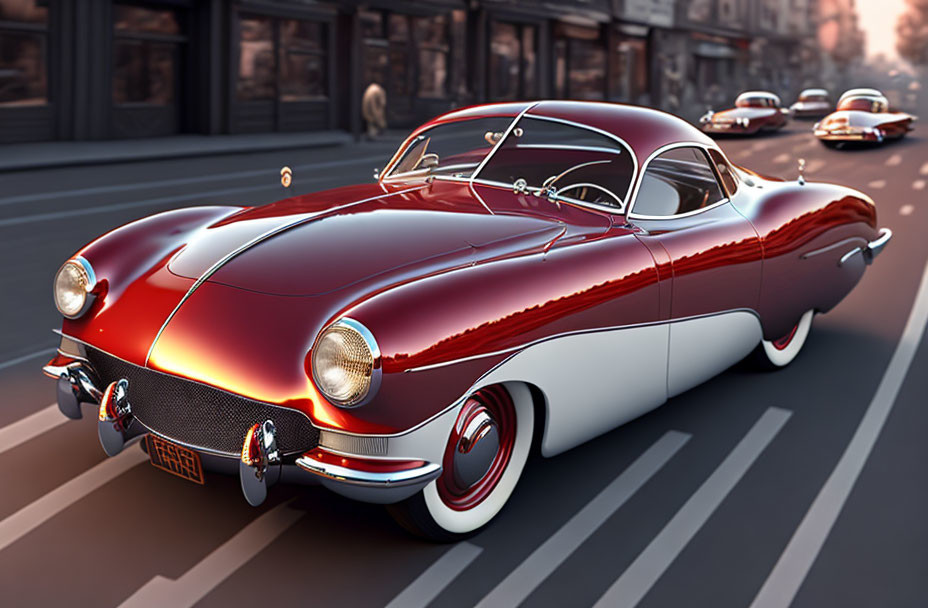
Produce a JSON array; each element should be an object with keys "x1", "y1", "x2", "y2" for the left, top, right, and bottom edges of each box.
[{"x1": 385, "y1": 116, "x2": 513, "y2": 179}]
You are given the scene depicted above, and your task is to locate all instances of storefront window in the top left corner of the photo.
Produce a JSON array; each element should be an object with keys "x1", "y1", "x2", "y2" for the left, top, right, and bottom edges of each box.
[{"x1": 0, "y1": 0, "x2": 48, "y2": 106}]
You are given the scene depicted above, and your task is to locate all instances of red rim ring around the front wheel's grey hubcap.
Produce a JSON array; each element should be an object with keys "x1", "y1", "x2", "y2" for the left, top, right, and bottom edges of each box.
[{"x1": 436, "y1": 386, "x2": 516, "y2": 511}]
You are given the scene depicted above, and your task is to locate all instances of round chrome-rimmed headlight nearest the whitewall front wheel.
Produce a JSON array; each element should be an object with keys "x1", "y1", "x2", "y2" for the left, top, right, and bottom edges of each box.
[{"x1": 312, "y1": 319, "x2": 380, "y2": 407}]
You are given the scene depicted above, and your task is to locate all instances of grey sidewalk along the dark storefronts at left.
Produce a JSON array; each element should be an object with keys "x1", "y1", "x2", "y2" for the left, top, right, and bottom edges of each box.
[{"x1": 0, "y1": 131, "x2": 354, "y2": 172}]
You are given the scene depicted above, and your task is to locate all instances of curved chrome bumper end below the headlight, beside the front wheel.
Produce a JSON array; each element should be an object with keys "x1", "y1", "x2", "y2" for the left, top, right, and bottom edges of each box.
[{"x1": 296, "y1": 456, "x2": 442, "y2": 504}]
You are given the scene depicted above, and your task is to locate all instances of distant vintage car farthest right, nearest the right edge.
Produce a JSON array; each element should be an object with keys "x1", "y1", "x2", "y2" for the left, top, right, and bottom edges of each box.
[{"x1": 812, "y1": 89, "x2": 918, "y2": 147}]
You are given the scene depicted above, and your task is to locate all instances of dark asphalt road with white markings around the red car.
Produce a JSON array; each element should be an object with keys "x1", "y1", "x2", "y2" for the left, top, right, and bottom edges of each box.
[{"x1": 0, "y1": 115, "x2": 928, "y2": 608}]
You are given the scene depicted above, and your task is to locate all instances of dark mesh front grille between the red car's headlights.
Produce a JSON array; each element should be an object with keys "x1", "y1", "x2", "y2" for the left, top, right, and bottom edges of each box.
[{"x1": 87, "y1": 347, "x2": 319, "y2": 457}]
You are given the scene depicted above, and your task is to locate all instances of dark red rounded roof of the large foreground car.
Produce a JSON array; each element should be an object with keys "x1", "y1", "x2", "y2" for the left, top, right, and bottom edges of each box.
[{"x1": 410, "y1": 101, "x2": 717, "y2": 166}]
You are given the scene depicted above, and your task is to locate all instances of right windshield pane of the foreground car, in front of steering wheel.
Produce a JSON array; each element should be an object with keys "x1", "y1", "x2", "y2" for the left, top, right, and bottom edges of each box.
[{"x1": 476, "y1": 115, "x2": 635, "y2": 210}]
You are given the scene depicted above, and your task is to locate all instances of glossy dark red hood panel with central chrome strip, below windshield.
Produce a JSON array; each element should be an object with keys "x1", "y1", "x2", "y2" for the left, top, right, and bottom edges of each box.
[{"x1": 168, "y1": 182, "x2": 564, "y2": 296}]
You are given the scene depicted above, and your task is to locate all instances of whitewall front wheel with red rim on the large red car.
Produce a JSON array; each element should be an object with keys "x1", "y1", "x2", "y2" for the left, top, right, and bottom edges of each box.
[{"x1": 387, "y1": 384, "x2": 534, "y2": 542}]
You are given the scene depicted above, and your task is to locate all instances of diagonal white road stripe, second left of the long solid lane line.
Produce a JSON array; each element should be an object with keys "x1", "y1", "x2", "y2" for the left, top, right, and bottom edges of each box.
[{"x1": 478, "y1": 431, "x2": 690, "y2": 608}]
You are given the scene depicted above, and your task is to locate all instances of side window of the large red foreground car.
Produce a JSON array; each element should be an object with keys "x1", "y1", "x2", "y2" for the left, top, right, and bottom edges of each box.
[{"x1": 632, "y1": 147, "x2": 725, "y2": 217}]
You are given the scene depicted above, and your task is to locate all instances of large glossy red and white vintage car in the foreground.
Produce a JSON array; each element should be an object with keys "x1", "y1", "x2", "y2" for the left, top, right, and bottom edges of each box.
[{"x1": 44, "y1": 101, "x2": 891, "y2": 540}]
